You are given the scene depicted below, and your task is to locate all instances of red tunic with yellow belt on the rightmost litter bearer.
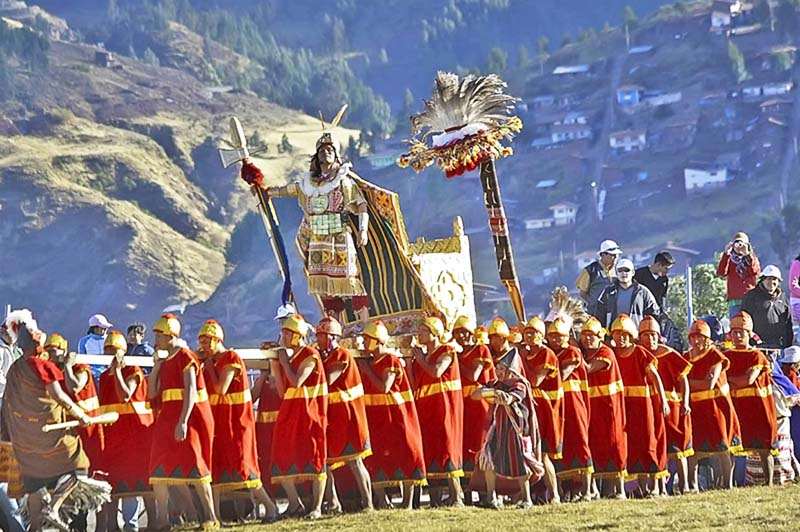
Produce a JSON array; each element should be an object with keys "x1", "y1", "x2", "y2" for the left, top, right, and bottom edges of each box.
[{"x1": 724, "y1": 349, "x2": 778, "y2": 456}]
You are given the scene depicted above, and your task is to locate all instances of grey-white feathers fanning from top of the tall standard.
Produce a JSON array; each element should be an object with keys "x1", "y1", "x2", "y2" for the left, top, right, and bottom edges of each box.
[{"x1": 411, "y1": 71, "x2": 518, "y2": 136}]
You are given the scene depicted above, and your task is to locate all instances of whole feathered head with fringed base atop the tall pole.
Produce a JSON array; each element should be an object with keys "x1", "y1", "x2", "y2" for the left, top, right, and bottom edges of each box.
[{"x1": 399, "y1": 72, "x2": 522, "y2": 178}]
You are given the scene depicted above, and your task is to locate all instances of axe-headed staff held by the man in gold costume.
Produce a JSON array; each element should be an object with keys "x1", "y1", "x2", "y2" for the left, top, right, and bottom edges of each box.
[{"x1": 219, "y1": 116, "x2": 297, "y2": 308}]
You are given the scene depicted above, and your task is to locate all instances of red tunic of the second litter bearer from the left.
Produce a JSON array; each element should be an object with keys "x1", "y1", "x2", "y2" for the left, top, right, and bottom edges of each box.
[{"x1": 100, "y1": 366, "x2": 153, "y2": 494}]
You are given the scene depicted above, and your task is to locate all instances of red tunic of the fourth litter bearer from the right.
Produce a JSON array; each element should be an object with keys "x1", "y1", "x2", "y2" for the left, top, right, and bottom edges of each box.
[{"x1": 614, "y1": 345, "x2": 667, "y2": 478}]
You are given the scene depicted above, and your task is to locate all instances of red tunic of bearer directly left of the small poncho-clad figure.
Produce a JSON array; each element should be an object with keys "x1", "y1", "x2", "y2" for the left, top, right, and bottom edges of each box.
[{"x1": 458, "y1": 345, "x2": 497, "y2": 477}]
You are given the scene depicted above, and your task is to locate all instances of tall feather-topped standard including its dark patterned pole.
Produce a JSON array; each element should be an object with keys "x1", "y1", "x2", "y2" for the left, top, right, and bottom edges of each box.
[{"x1": 399, "y1": 72, "x2": 525, "y2": 323}]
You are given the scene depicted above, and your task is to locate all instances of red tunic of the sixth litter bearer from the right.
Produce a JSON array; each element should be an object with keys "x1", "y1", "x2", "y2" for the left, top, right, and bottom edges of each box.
[{"x1": 557, "y1": 345, "x2": 594, "y2": 478}]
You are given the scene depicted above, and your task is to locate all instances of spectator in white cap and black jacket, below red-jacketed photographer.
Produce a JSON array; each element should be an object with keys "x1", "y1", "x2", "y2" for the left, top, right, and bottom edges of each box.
[{"x1": 742, "y1": 264, "x2": 794, "y2": 349}]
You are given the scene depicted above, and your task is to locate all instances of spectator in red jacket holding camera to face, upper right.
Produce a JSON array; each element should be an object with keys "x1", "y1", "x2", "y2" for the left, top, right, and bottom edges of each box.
[{"x1": 717, "y1": 233, "x2": 761, "y2": 316}]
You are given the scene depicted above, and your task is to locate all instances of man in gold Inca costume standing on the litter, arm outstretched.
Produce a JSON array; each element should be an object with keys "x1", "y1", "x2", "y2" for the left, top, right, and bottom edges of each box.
[{"x1": 242, "y1": 108, "x2": 370, "y2": 321}]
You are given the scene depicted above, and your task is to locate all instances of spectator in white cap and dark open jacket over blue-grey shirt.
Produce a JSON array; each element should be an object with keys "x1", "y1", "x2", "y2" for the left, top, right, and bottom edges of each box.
[{"x1": 597, "y1": 259, "x2": 659, "y2": 328}]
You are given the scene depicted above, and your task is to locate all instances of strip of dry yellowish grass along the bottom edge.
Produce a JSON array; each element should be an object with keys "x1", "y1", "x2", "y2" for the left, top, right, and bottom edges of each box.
[{"x1": 214, "y1": 485, "x2": 800, "y2": 532}]
